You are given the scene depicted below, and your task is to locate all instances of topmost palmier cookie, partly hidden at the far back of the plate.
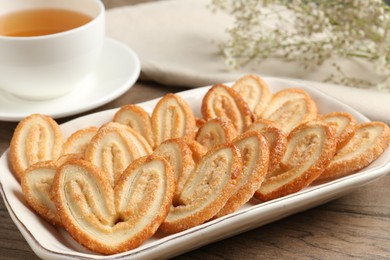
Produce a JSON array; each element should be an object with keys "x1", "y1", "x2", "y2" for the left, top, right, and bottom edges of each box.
[{"x1": 232, "y1": 75, "x2": 272, "y2": 118}]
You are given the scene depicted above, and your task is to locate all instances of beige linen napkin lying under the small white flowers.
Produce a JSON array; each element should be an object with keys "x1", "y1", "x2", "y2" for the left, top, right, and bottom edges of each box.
[{"x1": 106, "y1": 0, "x2": 390, "y2": 124}]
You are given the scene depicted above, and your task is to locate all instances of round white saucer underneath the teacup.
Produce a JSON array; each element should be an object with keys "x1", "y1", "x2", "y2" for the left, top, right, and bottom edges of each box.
[{"x1": 0, "y1": 38, "x2": 141, "y2": 121}]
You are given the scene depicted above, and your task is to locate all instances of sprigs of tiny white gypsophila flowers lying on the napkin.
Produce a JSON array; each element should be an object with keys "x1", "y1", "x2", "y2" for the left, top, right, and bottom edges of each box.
[{"x1": 211, "y1": 0, "x2": 390, "y2": 91}]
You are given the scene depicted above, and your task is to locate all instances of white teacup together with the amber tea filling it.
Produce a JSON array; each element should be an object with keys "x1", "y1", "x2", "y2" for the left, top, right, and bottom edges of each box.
[{"x1": 0, "y1": 0, "x2": 105, "y2": 101}]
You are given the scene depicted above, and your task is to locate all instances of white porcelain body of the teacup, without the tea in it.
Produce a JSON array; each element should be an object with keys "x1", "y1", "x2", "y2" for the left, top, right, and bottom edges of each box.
[{"x1": 0, "y1": 0, "x2": 105, "y2": 100}]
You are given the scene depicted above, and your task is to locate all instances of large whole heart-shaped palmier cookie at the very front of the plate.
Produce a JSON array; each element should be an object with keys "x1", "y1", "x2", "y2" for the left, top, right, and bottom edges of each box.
[{"x1": 53, "y1": 156, "x2": 174, "y2": 254}]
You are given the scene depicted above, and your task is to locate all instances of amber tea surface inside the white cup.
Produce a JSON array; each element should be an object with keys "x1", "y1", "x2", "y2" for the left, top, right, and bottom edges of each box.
[{"x1": 0, "y1": 9, "x2": 92, "y2": 37}]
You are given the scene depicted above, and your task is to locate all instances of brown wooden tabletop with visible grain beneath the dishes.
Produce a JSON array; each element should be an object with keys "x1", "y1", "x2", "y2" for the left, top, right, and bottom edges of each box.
[{"x1": 0, "y1": 0, "x2": 390, "y2": 259}]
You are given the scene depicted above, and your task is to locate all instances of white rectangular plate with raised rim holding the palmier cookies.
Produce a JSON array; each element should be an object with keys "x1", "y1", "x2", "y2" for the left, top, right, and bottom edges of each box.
[{"x1": 0, "y1": 77, "x2": 390, "y2": 259}]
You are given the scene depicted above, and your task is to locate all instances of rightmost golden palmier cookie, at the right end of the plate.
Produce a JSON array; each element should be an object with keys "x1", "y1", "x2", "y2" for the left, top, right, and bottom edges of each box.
[{"x1": 318, "y1": 122, "x2": 390, "y2": 180}]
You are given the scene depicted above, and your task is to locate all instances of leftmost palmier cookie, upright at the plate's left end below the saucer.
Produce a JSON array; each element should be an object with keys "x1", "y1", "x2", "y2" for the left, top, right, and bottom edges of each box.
[{"x1": 9, "y1": 114, "x2": 63, "y2": 180}]
